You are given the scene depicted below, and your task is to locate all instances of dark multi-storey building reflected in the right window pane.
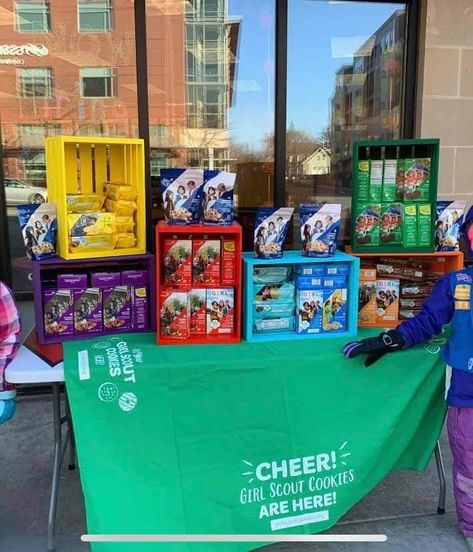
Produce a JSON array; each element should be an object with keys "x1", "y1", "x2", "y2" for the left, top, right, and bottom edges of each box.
[{"x1": 331, "y1": 10, "x2": 405, "y2": 187}]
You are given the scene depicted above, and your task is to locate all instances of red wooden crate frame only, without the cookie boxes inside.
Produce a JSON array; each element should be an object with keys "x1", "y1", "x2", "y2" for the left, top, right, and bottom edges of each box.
[{"x1": 156, "y1": 221, "x2": 243, "y2": 345}]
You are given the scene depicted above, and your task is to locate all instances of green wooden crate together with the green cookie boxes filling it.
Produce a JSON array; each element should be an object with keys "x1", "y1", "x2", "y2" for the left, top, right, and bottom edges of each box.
[{"x1": 352, "y1": 139, "x2": 439, "y2": 253}]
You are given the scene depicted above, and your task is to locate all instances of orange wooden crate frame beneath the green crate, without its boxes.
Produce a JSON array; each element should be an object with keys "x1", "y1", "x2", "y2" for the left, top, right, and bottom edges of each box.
[{"x1": 345, "y1": 247, "x2": 464, "y2": 328}]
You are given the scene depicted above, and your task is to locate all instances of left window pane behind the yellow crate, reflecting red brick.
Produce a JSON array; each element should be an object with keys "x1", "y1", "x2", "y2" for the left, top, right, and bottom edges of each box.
[{"x1": 0, "y1": 0, "x2": 138, "y2": 292}]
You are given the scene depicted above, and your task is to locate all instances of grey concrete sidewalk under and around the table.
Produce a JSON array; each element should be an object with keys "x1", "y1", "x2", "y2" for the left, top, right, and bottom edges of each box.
[{"x1": 0, "y1": 396, "x2": 467, "y2": 552}]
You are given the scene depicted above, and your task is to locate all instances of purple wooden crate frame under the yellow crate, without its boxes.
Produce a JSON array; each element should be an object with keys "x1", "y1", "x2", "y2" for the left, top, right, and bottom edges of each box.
[{"x1": 32, "y1": 253, "x2": 156, "y2": 345}]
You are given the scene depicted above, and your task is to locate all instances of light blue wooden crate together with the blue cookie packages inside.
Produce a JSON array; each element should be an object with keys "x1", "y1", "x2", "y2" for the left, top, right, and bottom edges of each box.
[{"x1": 243, "y1": 251, "x2": 359, "y2": 341}]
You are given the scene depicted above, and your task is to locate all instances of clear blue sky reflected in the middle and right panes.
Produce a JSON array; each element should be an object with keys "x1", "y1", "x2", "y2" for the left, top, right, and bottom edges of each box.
[{"x1": 228, "y1": 0, "x2": 403, "y2": 148}]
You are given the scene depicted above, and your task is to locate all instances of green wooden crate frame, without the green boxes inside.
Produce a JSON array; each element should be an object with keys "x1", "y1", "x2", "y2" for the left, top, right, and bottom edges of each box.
[{"x1": 351, "y1": 138, "x2": 440, "y2": 254}]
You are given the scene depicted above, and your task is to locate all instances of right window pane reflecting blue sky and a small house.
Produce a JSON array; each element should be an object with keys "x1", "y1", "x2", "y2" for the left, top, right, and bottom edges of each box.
[{"x1": 286, "y1": 0, "x2": 406, "y2": 237}]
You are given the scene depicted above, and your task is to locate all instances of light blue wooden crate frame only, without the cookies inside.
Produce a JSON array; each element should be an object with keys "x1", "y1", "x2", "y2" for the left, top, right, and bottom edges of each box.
[{"x1": 243, "y1": 251, "x2": 360, "y2": 342}]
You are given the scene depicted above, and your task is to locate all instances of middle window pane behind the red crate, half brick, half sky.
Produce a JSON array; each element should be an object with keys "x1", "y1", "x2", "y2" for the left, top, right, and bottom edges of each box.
[{"x1": 146, "y1": 0, "x2": 276, "y2": 216}]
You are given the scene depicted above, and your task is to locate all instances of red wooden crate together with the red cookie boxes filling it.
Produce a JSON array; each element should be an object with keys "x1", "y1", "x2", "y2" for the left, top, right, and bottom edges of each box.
[{"x1": 156, "y1": 222, "x2": 241, "y2": 345}]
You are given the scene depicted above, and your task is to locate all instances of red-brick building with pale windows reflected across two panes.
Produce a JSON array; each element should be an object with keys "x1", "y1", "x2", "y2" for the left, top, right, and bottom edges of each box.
[{"x1": 0, "y1": 0, "x2": 240, "y2": 186}]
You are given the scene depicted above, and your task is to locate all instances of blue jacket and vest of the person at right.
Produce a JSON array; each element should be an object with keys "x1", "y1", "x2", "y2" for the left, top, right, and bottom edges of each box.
[{"x1": 397, "y1": 269, "x2": 473, "y2": 408}]
